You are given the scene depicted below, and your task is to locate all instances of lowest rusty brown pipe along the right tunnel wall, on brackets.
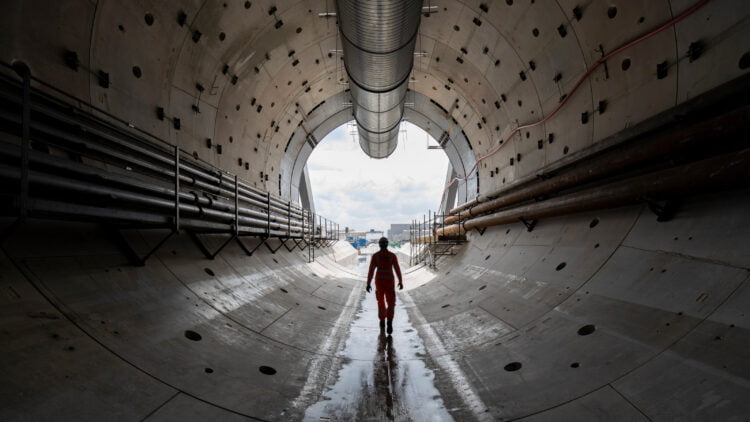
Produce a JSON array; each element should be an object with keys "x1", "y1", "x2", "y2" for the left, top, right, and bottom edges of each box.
[{"x1": 435, "y1": 149, "x2": 750, "y2": 236}]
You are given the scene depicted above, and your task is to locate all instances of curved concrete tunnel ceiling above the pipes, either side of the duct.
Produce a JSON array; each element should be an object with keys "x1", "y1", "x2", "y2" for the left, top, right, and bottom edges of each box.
[{"x1": 0, "y1": 0, "x2": 750, "y2": 204}]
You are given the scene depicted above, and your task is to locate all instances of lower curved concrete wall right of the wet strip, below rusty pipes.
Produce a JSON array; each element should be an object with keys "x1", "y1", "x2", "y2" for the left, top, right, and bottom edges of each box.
[{"x1": 407, "y1": 192, "x2": 750, "y2": 421}]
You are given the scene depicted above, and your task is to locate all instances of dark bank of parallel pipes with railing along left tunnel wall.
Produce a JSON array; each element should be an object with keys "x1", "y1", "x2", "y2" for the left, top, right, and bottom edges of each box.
[{"x1": 0, "y1": 63, "x2": 339, "y2": 264}]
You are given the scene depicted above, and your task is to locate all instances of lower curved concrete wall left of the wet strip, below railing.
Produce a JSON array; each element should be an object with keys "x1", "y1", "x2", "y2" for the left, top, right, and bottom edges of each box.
[{"x1": 0, "y1": 219, "x2": 364, "y2": 421}]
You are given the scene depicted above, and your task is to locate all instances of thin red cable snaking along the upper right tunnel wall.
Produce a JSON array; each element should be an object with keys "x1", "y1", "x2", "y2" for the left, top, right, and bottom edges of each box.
[{"x1": 440, "y1": 0, "x2": 711, "y2": 213}]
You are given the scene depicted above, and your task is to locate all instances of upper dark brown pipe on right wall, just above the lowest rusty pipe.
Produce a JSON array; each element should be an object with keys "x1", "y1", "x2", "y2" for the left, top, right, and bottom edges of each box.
[{"x1": 445, "y1": 107, "x2": 750, "y2": 224}]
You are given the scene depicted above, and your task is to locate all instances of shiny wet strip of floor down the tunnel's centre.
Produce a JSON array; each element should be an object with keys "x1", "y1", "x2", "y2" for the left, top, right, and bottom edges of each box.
[{"x1": 304, "y1": 263, "x2": 453, "y2": 421}]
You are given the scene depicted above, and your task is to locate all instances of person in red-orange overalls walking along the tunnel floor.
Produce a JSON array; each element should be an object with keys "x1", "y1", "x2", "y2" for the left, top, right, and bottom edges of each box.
[{"x1": 367, "y1": 237, "x2": 404, "y2": 334}]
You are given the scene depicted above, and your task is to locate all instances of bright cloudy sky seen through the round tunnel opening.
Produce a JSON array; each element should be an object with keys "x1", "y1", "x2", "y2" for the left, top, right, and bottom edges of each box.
[{"x1": 307, "y1": 122, "x2": 448, "y2": 232}]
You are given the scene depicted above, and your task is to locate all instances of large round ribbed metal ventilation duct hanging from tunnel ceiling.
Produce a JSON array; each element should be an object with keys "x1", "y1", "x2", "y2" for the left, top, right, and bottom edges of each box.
[{"x1": 336, "y1": 0, "x2": 422, "y2": 158}]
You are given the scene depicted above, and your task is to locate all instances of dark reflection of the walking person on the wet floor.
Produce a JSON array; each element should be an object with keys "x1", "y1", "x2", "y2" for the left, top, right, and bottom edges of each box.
[{"x1": 373, "y1": 332, "x2": 399, "y2": 420}]
